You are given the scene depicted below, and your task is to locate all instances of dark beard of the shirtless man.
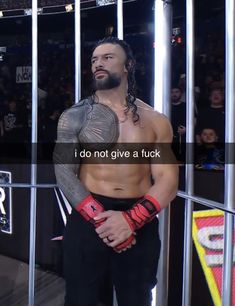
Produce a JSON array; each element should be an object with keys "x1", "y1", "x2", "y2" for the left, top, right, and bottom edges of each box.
[{"x1": 92, "y1": 70, "x2": 121, "y2": 91}]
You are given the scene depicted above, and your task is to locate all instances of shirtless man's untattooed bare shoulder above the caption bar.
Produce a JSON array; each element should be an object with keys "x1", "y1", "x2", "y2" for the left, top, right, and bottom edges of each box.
[{"x1": 136, "y1": 99, "x2": 173, "y2": 142}]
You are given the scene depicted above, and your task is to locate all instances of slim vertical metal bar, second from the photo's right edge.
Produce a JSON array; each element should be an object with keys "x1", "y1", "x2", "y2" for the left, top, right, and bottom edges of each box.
[{"x1": 182, "y1": 0, "x2": 194, "y2": 306}]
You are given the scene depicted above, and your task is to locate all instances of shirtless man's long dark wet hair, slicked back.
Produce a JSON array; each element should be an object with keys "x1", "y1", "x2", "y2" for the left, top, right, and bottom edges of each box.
[{"x1": 93, "y1": 36, "x2": 140, "y2": 123}]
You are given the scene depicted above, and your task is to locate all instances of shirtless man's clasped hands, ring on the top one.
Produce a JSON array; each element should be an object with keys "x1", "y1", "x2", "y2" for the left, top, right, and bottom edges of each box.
[{"x1": 94, "y1": 210, "x2": 136, "y2": 253}]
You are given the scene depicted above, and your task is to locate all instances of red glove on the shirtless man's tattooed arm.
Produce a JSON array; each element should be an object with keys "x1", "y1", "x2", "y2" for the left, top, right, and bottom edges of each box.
[{"x1": 76, "y1": 195, "x2": 134, "y2": 252}]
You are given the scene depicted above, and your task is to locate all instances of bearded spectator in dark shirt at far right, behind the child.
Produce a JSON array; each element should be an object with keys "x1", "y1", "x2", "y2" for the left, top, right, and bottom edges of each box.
[{"x1": 196, "y1": 88, "x2": 225, "y2": 142}]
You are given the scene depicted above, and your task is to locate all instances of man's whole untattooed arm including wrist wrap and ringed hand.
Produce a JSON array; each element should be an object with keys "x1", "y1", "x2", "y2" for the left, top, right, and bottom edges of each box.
[{"x1": 96, "y1": 115, "x2": 178, "y2": 247}]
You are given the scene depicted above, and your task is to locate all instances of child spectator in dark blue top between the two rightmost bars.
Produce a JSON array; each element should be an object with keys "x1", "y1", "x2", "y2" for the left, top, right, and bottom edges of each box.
[{"x1": 195, "y1": 128, "x2": 224, "y2": 170}]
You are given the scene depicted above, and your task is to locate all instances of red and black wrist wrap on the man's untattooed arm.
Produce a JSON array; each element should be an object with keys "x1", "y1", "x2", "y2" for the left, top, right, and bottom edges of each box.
[{"x1": 123, "y1": 195, "x2": 161, "y2": 232}]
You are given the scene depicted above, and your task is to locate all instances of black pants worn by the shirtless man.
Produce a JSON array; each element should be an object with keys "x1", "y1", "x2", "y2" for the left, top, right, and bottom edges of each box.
[{"x1": 64, "y1": 194, "x2": 160, "y2": 306}]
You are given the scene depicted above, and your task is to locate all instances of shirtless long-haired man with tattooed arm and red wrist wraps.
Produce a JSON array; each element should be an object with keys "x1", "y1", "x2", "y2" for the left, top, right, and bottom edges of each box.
[{"x1": 54, "y1": 38, "x2": 178, "y2": 306}]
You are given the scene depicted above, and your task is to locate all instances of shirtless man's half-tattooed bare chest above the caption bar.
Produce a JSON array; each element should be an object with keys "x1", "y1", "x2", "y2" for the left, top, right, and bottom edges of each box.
[{"x1": 78, "y1": 104, "x2": 157, "y2": 144}]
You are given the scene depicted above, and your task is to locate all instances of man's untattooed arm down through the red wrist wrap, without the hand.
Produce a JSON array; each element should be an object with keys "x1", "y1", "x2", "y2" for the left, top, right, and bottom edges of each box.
[{"x1": 118, "y1": 114, "x2": 178, "y2": 231}]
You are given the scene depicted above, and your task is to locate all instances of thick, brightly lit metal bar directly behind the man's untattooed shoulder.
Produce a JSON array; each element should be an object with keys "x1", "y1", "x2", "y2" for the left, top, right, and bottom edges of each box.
[{"x1": 152, "y1": 0, "x2": 172, "y2": 306}]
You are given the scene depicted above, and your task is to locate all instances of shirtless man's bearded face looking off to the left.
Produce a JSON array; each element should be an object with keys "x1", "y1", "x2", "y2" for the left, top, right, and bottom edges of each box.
[{"x1": 91, "y1": 44, "x2": 127, "y2": 90}]
